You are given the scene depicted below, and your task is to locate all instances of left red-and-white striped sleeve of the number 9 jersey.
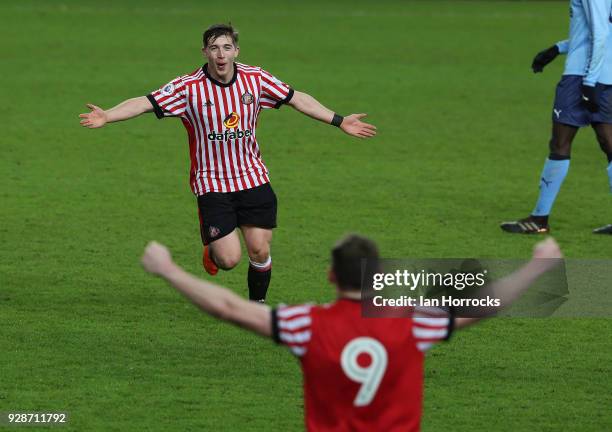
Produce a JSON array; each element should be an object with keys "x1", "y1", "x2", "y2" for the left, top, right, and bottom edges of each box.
[{"x1": 272, "y1": 305, "x2": 312, "y2": 357}]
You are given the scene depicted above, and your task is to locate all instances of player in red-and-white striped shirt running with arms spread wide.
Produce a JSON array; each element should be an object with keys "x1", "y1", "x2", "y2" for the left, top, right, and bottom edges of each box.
[{"x1": 80, "y1": 24, "x2": 376, "y2": 301}]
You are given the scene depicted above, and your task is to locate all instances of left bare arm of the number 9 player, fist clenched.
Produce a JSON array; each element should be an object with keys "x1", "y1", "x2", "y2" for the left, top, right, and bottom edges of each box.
[{"x1": 142, "y1": 242, "x2": 272, "y2": 337}]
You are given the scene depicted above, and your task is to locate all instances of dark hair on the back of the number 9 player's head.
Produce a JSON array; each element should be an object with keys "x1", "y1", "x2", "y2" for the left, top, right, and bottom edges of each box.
[{"x1": 332, "y1": 234, "x2": 379, "y2": 291}]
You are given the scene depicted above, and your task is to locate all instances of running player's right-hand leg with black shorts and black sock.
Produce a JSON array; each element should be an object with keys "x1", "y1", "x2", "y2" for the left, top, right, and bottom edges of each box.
[{"x1": 236, "y1": 183, "x2": 276, "y2": 302}]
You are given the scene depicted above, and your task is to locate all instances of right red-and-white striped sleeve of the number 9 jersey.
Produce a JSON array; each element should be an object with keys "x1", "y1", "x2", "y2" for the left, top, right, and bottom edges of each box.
[{"x1": 412, "y1": 307, "x2": 455, "y2": 352}]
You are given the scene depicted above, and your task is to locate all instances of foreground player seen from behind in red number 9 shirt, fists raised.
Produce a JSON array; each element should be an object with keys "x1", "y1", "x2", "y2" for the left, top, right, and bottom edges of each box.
[{"x1": 142, "y1": 235, "x2": 562, "y2": 431}]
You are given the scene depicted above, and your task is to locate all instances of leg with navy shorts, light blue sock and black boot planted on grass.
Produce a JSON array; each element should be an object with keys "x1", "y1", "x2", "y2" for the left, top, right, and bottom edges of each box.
[{"x1": 501, "y1": 75, "x2": 590, "y2": 234}]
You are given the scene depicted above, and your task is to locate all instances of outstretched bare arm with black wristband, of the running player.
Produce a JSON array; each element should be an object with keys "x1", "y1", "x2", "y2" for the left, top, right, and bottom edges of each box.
[{"x1": 289, "y1": 91, "x2": 376, "y2": 138}]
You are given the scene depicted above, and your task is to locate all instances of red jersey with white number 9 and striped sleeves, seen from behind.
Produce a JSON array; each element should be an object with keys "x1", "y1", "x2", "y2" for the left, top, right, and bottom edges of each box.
[{"x1": 272, "y1": 299, "x2": 452, "y2": 431}]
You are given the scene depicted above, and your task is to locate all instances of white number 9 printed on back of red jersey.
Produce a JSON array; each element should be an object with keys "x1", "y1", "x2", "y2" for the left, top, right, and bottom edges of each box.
[{"x1": 340, "y1": 337, "x2": 387, "y2": 406}]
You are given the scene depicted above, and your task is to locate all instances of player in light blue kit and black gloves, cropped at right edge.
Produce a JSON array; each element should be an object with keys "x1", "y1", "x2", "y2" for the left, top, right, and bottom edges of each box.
[{"x1": 501, "y1": 0, "x2": 612, "y2": 234}]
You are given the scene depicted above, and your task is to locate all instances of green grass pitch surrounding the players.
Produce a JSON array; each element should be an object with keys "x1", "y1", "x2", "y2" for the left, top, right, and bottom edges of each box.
[{"x1": 0, "y1": 0, "x2": 612, "y2": 431}]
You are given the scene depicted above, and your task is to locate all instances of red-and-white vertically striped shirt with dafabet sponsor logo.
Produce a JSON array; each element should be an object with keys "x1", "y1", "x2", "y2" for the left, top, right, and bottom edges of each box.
[{"x1": 147, "y1": 63, "x2": 293, "y2": 195}]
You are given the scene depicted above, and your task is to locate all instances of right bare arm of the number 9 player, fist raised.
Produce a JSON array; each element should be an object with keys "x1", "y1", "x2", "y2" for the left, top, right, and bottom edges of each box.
[{"x1": 455, "y1": 237, "x2": 563, "y2": 329}]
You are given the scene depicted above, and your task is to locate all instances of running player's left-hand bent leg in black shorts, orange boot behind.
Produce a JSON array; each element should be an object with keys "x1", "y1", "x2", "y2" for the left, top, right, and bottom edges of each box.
[{"x1": 198, "y1": 192, "x2": 241, "y2": 276}]
